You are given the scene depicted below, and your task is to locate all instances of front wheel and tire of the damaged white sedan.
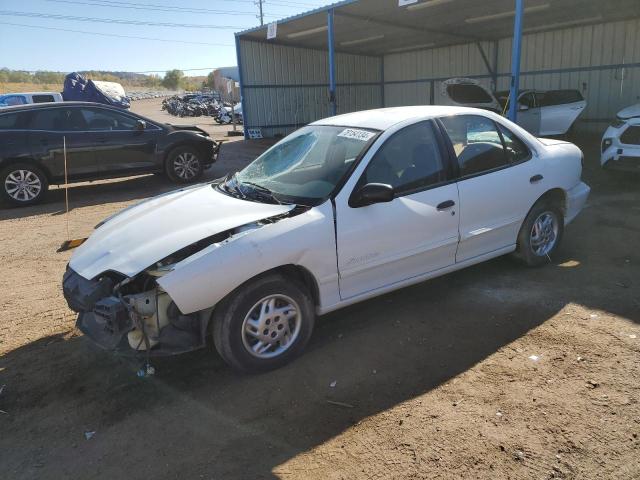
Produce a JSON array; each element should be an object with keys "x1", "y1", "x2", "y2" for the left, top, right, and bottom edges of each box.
[{"x1": 213, "y1": 274, "x2": 315, "y2": 373}]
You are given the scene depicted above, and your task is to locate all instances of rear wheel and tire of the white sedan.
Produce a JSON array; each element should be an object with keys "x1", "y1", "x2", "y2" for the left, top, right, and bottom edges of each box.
[{"x1": 516, "y1": 201, "x2": 564, "y2": 267}]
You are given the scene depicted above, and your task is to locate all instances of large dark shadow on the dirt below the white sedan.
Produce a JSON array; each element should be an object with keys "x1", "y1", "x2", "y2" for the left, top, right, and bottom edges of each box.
[{"x1": 0, "y1": 239, "x2": 640, "y2": 478}]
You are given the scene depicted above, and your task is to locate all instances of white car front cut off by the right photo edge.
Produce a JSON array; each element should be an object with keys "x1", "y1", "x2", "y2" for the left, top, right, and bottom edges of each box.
[{"x1": 600, "y1": 103, "x2": 640, "y2": 171}]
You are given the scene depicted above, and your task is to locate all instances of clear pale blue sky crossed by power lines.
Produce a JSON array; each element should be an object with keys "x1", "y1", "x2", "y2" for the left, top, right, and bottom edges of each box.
[{"x1": 0, "y1": 0, "x2": 333, "y2": 75}]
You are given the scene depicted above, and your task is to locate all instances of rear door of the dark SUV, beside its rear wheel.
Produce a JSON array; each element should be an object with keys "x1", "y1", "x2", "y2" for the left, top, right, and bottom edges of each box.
[{"x1": 29, "y1": 105, "x2": 98, "y2": 178}]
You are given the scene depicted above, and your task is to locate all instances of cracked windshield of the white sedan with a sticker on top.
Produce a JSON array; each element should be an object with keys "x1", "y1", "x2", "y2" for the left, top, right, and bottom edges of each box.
[{"x1": 225, "y1": 125, "x2": 378, "y2": 205}]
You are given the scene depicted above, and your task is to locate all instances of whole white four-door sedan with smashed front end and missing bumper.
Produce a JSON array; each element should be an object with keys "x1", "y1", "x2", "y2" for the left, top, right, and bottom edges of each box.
[{"x1": 63, "y1": 106, "x2": 589, "y2": 371}]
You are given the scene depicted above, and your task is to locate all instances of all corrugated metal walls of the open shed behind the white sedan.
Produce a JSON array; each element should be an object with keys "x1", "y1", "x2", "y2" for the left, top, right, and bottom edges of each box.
[{"x1": 240, "y1": 19, "x2": 640, "y2": 136}]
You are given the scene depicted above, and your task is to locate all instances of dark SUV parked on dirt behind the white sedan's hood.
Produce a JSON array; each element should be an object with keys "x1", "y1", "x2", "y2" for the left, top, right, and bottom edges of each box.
[{"x1": 0, "y1": 102, "x2": 220, "y2": 205}]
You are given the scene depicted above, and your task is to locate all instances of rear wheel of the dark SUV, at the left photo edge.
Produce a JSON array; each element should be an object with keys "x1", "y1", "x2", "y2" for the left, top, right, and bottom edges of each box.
[{"x1": 0, "y1": 162, "x2": 49, "y2": 206}]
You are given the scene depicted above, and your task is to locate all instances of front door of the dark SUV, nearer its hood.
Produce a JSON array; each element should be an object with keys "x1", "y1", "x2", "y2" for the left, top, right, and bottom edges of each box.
[{"x1": 82, "y1": 106, "x2": 162, "y2": 174}]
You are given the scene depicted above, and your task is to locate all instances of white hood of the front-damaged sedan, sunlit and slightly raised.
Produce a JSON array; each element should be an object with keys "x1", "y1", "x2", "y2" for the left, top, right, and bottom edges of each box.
[{"x1": 69, "y1": 184, "x2": 293, "y2": 280}]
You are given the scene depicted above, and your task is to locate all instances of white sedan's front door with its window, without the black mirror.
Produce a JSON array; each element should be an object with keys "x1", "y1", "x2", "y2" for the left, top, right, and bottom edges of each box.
[{"x1": 336, "y1": 121, "x2": 459, "y2": 300}]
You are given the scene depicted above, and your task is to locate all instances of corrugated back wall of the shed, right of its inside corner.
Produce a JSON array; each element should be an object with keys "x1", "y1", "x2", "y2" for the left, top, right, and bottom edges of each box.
[{"x1": 384, "y1": 19, "x2": 640, "y2": 121}]
